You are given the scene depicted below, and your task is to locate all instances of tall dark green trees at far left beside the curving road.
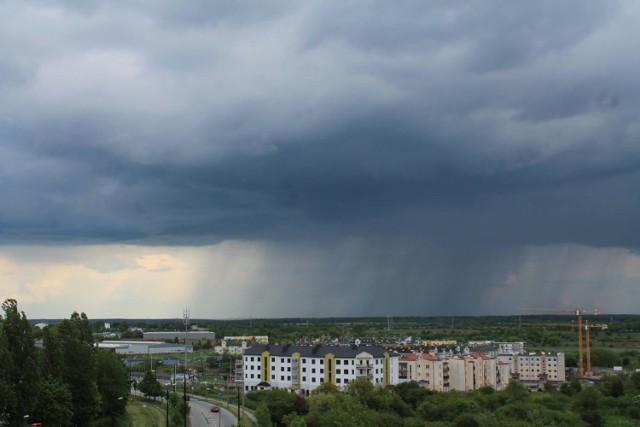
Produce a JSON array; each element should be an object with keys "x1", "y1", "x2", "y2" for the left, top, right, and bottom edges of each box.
[{"x1": 0, "y1": 299, "x2": 130, "y2": 426}]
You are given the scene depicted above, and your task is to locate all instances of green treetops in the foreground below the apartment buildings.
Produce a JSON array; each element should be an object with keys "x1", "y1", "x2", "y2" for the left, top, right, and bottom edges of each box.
[{"x1": 246, "y1": 374, "x2": 640, "y2": 427}]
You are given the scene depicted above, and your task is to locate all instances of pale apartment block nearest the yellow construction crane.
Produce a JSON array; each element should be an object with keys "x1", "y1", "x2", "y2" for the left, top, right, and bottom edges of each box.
[{"x1": 497, "y1": 352, "x2": 565, "y2": 382}]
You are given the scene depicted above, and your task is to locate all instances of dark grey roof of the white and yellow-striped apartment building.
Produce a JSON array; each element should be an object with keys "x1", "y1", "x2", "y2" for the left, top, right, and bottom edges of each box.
[{"x1": 244, "y1": 344, "x2": 398, "y2": 358}]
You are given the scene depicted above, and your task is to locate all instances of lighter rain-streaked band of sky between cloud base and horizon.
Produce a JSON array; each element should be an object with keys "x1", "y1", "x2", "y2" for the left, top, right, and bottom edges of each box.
[{"x1": 0, "y1": 241, "x2": 640, "y2": 318}]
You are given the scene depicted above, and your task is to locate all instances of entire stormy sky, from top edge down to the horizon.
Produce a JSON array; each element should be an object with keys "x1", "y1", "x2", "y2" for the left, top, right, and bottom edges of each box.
[{"x1": 0, "y1": 0, "x2": 640, "y2": 318}]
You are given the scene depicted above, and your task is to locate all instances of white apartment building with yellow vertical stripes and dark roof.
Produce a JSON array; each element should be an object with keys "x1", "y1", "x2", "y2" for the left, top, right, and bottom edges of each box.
[{"x1": 243, "y1": 345, "x2": 399, "y2": 395}]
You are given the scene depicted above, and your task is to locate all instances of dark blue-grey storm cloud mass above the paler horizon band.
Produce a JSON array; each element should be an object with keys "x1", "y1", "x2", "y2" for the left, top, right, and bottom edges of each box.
[{"x1": 0, "y1": 1, "x2": 640, "y2": 247}]
